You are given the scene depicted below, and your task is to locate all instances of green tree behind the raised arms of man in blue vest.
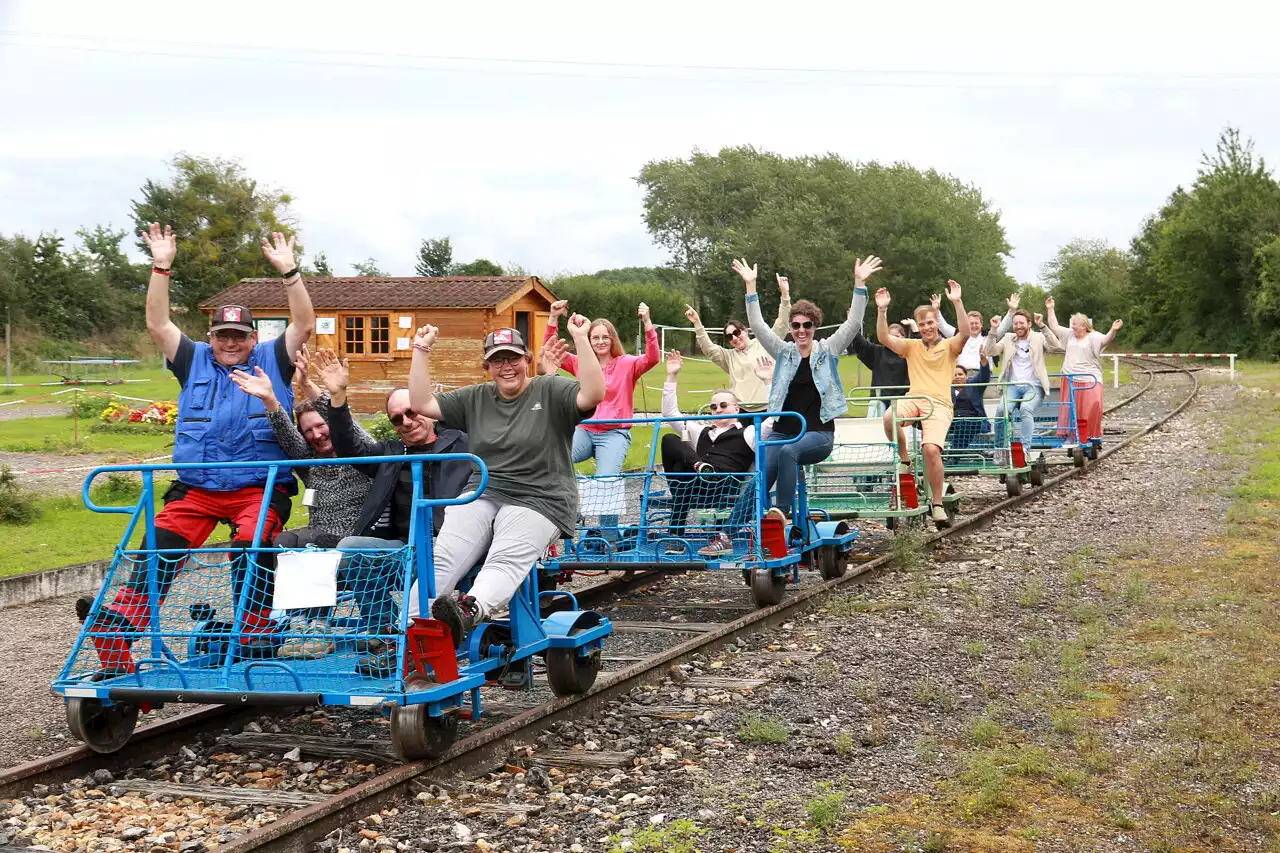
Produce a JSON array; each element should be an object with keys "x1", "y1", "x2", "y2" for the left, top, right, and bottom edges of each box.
[{"x1": 133, "y1": 154, "x2": 294, "y2": 311}]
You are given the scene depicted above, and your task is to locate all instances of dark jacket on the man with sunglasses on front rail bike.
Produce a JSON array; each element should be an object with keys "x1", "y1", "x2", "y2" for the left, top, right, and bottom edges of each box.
[{"x1": 329, "y1": 406, "x2": 471, "y2": 537}]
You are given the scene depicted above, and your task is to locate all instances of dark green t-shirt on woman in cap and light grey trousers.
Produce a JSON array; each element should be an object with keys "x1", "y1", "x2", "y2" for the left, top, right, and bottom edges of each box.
[{"x1": 435, "y1": 375, "x2": 591, "y2": 537}]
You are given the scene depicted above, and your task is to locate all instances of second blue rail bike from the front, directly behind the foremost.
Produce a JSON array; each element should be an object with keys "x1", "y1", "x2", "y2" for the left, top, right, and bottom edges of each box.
[{"x1": 543, "y1": 411, "x2": 858, "y2": 607}]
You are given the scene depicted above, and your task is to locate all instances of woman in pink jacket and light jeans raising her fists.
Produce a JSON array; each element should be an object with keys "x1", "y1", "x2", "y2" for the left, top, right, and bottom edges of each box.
[{"x1": 543, "y1": 300, "x2": 662, "y2": 540}]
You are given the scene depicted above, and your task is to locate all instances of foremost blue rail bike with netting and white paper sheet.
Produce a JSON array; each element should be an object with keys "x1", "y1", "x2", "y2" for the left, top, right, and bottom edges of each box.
[{"x1": 52, "y1": 453, "x2": 612, "y2": 761}]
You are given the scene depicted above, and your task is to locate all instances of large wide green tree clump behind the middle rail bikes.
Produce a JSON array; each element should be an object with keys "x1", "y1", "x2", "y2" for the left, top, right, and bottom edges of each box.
[{"x1": 636, "y1": 147, "x2": 1016, "y2": 323}]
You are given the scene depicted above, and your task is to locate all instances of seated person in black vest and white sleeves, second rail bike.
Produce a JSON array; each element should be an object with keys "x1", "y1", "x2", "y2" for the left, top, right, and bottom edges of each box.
[{"x1": 659, "y1": 350, "x2": 773, "y2": 538}]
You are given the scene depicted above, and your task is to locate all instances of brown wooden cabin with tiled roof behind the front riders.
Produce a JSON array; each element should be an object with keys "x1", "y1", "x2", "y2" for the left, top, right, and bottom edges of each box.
[{"x1": 200, "y1": 275, "x2": 556, "y2": 412}]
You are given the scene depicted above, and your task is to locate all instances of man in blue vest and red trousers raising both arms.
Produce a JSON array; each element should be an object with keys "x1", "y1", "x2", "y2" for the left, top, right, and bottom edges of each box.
[{"x1": 77, "y1": 223, "x2": 315, "y2": 671}]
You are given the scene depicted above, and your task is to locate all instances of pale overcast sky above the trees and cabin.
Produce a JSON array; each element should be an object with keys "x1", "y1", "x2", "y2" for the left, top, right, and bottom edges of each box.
[{"x1": 0, "y1": 0, "x2": 1280, "y2": 280}]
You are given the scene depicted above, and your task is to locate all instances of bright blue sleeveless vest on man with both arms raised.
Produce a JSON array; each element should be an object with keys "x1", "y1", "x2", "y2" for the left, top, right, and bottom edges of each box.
[{"x1": 173, "y1": 341, "x2": 297, "y2": 494}]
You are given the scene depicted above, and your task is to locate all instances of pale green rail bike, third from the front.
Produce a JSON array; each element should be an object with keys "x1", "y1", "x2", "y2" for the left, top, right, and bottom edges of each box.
[{"x1": 806, "y1": 388, "x2": 936, "y2": 530}]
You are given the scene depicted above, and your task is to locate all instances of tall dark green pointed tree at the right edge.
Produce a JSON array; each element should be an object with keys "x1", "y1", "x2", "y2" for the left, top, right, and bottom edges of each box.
[{"x1": 1125, "y1": 127, "x2": 1280, "y2": 357}]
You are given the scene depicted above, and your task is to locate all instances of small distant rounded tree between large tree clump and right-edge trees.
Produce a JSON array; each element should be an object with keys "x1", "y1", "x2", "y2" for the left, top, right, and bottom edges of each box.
[{"x1": 1041, "y1": 240, "x2": 1133, "y2": 327}]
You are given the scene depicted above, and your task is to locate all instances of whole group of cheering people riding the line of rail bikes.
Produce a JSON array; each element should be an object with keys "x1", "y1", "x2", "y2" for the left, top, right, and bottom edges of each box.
[{"x1": 77, "y1": 224, "x2": 1121, "y2": 675}]
